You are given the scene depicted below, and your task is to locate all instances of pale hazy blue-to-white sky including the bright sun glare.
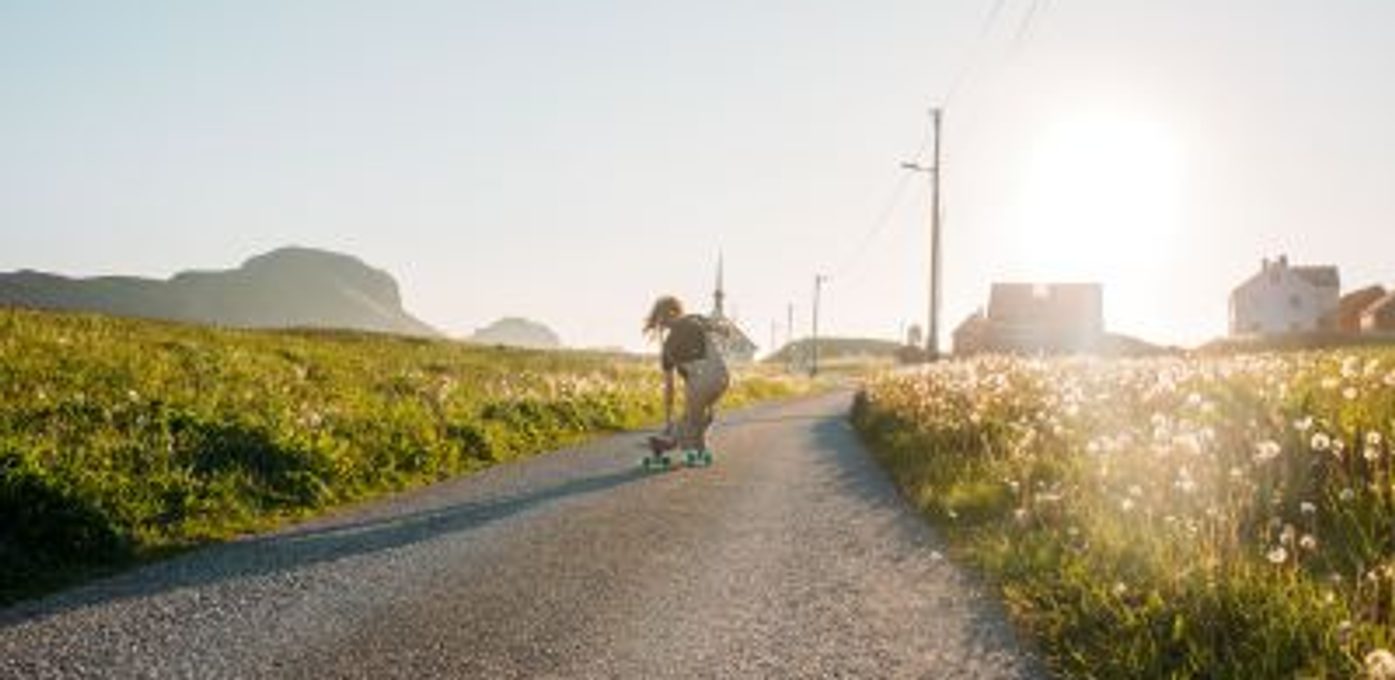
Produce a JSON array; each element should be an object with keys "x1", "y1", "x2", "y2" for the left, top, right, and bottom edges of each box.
[{"x1": 0, "y1": 0, "x2": 1395, "y2": 349}]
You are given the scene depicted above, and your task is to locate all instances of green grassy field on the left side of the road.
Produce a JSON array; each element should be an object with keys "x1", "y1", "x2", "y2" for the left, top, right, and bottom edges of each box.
[{"x1": 0, "y1": 309, "x2": 809, "y2": 603}]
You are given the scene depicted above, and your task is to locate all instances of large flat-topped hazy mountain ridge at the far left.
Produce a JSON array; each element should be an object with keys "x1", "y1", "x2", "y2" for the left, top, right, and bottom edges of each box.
[{"x1": 0, "y1": 247, "x2": 441, "y2": 337}]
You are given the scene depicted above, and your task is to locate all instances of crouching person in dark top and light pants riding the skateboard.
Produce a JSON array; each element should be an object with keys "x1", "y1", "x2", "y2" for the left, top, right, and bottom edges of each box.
[{"x1": 644, "y1": 295, "x2": 731, "y2": 464}]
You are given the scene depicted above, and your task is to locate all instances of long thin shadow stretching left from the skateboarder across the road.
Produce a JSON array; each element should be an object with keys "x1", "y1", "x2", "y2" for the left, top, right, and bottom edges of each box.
[{"x1": 0, "y1": 468, "x2": 651, "y2": 627}]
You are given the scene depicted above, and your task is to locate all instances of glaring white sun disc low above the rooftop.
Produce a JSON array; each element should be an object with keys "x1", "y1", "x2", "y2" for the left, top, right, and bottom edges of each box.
[{"x1": 1017, "y1": 112, "x2": 1182, "y2": 283}]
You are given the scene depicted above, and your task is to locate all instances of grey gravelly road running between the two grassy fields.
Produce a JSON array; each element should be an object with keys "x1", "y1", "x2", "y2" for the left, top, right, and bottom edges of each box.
[{"x1": 0, "y1": 394, "x2": 1042, "y2": 679}]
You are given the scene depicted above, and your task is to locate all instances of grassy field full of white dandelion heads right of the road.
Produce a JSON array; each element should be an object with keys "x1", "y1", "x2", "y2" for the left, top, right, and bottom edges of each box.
[{"x1": 854, "y1": 349, "x2": 1395, "y2": 679}]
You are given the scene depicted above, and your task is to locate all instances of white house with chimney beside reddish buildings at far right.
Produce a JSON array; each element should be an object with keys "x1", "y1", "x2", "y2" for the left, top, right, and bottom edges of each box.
[{"x1": 1230, "y1": 256, "x2": 1342, "y2": 337}]
